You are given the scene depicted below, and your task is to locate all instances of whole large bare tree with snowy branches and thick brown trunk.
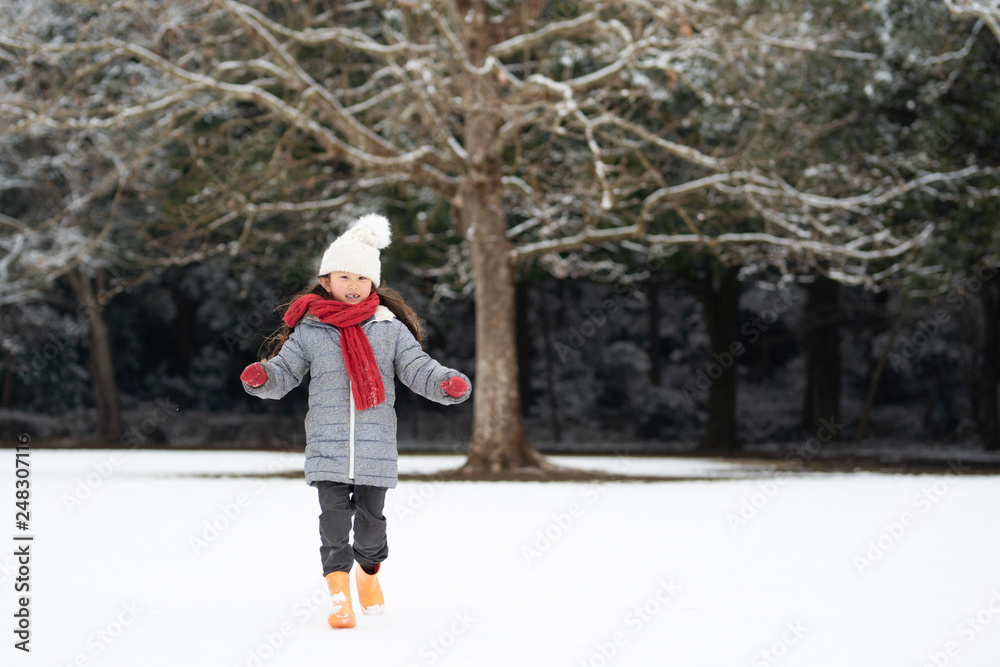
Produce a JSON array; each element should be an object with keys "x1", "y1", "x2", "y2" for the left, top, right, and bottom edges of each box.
[{"x1": 0, "y1": 0, "x2": 981, "y2": 464}]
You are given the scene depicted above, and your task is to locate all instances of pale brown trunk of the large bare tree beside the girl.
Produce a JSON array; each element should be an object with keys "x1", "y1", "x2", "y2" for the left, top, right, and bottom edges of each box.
[{"x1": 452, "y1": 20, "x2": 543, "y2": 474}]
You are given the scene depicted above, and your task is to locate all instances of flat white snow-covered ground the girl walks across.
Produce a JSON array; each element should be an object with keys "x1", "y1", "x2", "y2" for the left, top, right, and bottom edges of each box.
[{"x1": 0, "y1": 450, "x2": 1000, "y2": 667}]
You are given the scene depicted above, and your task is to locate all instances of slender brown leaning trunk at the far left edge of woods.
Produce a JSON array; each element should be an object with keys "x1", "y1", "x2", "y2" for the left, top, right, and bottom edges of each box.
[{"x1": 66, "y1": 268, "x2": 122, "y2": 444}]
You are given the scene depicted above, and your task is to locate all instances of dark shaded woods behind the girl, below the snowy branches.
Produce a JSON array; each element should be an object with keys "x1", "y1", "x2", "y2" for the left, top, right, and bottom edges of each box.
[{"x1": 0, "y1": 252, "x2": 1000, "y2": 452}]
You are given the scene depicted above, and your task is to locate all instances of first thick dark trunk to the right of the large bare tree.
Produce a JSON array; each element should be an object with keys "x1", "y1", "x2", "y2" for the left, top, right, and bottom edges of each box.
[{"x1": 699, "y1": 267, "x2": 740, "y2": 452}]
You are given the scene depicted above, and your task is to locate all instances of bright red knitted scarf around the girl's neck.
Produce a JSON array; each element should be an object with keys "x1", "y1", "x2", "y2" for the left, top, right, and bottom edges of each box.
[{"x1": 285, "y1": 292, "x2": 385, "y2": 410}]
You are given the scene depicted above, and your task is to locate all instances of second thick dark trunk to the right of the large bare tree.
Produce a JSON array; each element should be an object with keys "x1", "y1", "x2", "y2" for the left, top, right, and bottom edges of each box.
[{"x1": 802, "y1": 276, "x2": 841, "y2": 435}]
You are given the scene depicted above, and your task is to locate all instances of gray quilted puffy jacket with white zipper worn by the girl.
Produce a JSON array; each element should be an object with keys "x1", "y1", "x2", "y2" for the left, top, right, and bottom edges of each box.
[{"x1": 243, "y1": 306, "x2": 472, "y2": 488}]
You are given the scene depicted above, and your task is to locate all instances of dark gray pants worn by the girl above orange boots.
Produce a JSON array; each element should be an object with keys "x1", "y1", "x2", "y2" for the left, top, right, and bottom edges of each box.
[{"x1": 316, "y1": 482, "x2": 389, "y2": 577}]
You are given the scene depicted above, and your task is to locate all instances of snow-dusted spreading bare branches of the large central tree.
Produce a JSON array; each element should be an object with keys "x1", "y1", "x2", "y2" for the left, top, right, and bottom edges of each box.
[{"x1": 0, "y1": 0, "x2": 984, "y2": 300}]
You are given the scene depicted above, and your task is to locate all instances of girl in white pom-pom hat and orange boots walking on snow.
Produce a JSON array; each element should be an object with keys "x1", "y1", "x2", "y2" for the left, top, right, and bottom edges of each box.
[{"x1": 240, "y1": 214, "x2": 470, "y2": 628}]
